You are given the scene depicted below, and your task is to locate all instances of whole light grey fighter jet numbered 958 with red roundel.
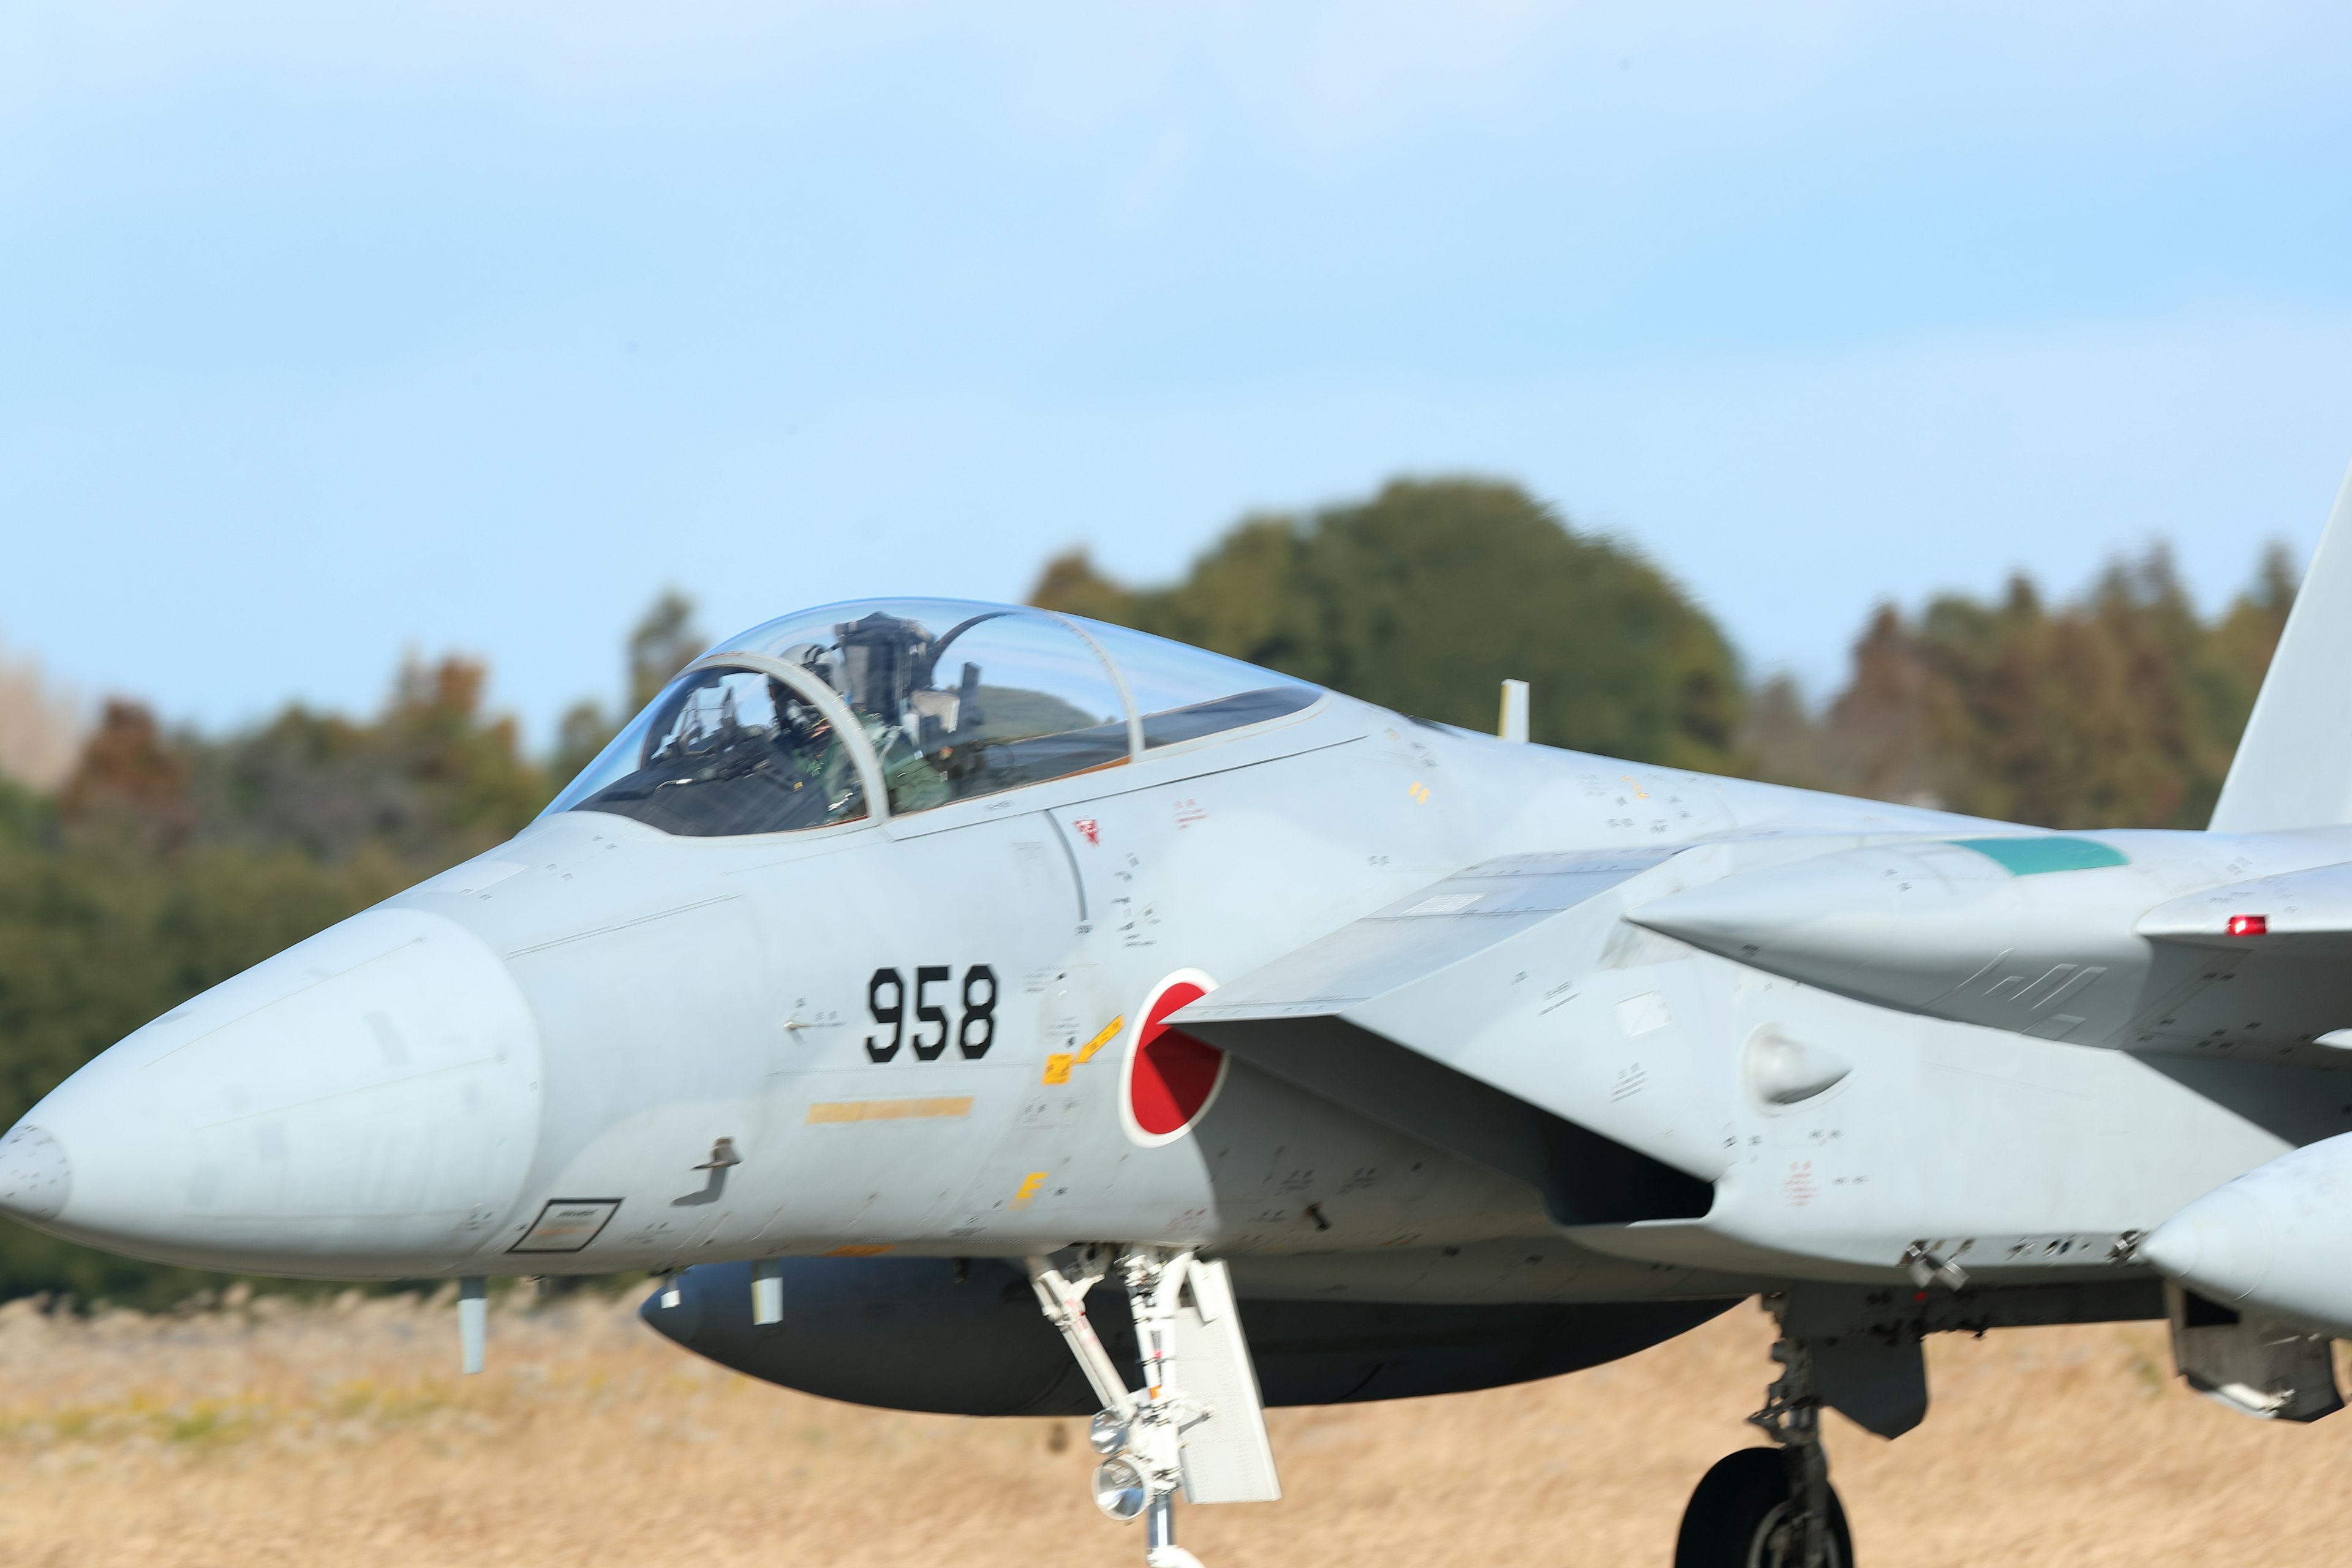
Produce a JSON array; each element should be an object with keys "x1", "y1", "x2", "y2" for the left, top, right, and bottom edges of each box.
[{"x1": 13, "y1": 489, "x2": 2352, "y2": 1568}]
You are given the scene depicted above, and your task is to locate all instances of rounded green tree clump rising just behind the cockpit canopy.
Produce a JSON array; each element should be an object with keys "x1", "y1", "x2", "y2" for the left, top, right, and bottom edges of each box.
[{"x1": 1030, "y1": 480, "x2": 1743, "y2": 771}]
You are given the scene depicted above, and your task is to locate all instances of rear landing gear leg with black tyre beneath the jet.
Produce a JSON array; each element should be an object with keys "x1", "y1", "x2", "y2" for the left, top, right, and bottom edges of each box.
[{"x1": 1675, "y1": 1319, "x2": 1853, "y2": 1568}]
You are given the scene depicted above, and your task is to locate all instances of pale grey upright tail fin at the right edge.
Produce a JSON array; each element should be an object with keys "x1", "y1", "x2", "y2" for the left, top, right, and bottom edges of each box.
[{"x1": 2211, "y1": 461, "x2": 2352, "y2": 832}]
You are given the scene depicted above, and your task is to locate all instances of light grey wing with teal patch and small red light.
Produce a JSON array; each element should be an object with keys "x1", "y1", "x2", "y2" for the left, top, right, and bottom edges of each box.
[{"x1": 1627, "y1": 835, "x2": 2352, "y2": 1067}]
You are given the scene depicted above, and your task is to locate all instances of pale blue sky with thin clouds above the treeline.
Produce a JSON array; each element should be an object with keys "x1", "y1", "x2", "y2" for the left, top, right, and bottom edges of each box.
[{"x1": 0, "y1": 0, "x2": 2352, "y2": 733}]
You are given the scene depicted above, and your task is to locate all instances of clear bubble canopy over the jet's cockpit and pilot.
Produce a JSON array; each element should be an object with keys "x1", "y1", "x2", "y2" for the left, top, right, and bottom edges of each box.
[{"x1": 548, "y1": 600, "x2": 1322, "y2": 837}]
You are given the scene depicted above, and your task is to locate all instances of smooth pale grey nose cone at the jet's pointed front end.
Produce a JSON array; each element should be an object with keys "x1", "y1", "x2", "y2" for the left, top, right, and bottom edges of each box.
[{"x1": 18, "y1": 907, "x2": 541, "y2": 1276}]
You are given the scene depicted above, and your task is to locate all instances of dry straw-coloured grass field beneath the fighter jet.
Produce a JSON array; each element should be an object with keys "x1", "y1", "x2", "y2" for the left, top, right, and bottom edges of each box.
[{"x1": 0, "y1": 1298, "x2": 2352, "y2": 1568}]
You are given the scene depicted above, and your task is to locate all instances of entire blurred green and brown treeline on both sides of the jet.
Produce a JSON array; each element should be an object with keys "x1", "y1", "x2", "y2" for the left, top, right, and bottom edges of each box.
[{"x1": 0, "y1": 480, "x2": 2293, "y2": 1307}]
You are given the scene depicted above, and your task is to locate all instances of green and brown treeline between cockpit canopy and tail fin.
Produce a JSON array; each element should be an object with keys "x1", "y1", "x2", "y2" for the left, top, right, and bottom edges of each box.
[{"x1": 1033, "y1": 480, "x2": 2298, "y2": 827}]
